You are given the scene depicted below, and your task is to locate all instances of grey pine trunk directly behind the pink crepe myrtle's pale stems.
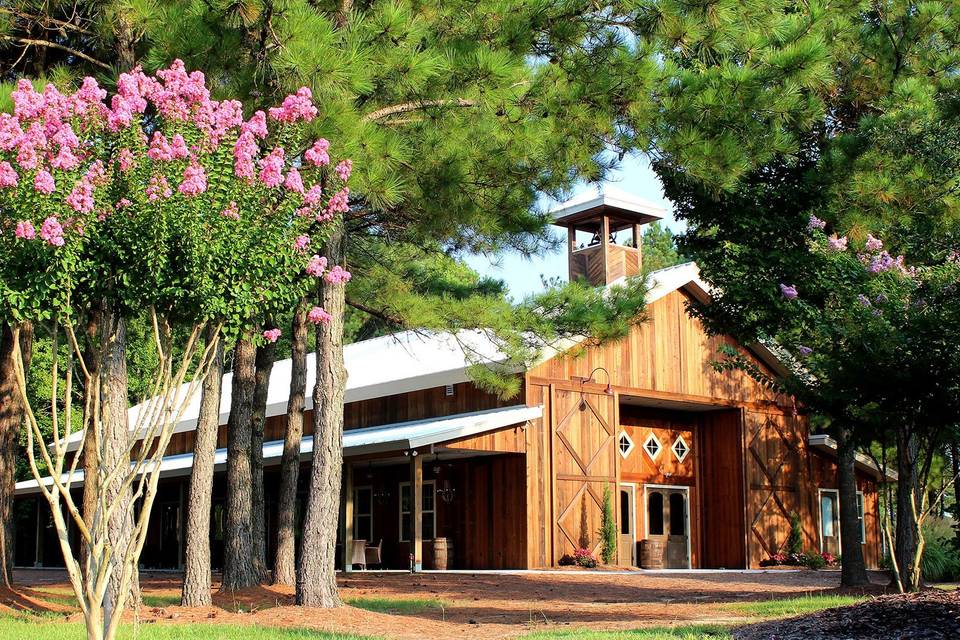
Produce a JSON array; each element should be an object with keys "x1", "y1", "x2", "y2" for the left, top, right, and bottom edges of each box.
[{"x1": 100, "y1": 306, "x2": 140, "y2": 620}]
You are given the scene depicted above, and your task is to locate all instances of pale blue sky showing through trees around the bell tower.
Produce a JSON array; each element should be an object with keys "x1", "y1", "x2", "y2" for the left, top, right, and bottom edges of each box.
[{"x1": 467, "y1": 156, "x2": 683, "y2": 300}]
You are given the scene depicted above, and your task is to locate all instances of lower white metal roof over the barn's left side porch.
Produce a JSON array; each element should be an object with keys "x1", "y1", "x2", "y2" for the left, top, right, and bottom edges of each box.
[{"x1": 16, "y1": 405, "x2": 543, "y2": 496}]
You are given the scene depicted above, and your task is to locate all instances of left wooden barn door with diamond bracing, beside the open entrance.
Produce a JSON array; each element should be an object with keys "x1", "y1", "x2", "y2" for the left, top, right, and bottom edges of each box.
[{"x1": 552, "y1": 389, "x2": 617, "y2": 563}]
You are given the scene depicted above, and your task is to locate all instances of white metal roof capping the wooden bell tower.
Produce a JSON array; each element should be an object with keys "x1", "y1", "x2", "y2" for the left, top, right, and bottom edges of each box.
[{"x1": 550, "y1": 185, "x2": 667, "y2": 231}]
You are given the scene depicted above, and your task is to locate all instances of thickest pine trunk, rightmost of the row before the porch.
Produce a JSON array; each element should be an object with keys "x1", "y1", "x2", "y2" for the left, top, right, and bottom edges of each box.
[{"x1": 297, "y1": 227, "x2": 347, "y2": 607}]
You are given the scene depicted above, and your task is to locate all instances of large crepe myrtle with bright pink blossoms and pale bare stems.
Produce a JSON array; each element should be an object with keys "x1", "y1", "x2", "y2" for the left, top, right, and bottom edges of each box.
[{"x1": 0, "y1": 61, "x2": 347, "y2": 639}]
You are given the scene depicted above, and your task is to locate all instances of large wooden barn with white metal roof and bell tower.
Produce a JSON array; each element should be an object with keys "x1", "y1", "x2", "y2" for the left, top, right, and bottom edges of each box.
[{"x1": 15, "y1": 190, "x2": 881, "y2": 569}]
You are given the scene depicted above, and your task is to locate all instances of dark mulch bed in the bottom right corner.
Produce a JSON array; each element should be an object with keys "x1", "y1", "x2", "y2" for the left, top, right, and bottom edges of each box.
[{"x1": 733, "y1": 589, "x2": 960, "y2": 640}]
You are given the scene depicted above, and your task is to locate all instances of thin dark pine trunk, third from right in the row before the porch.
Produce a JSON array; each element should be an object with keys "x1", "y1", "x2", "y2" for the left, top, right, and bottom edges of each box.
[{"x1": 250, "y1": 342, "x2": 277, "y2": 582}]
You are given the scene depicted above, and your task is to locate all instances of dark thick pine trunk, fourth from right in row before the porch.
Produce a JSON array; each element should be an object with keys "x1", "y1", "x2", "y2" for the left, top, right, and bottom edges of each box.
[{"x1": 220, "y1": 339, "x2": 259, "y2": 591}]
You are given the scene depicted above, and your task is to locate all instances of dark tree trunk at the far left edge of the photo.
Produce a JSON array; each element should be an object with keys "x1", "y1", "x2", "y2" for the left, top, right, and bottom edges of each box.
[{"x1": 0, "y1": 322, "x2": 33, "y2": 587}]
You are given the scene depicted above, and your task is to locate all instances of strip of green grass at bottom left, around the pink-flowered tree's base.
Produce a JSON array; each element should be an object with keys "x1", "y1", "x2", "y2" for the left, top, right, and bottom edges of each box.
[{"x1": 0, "y1": 616, "x2": 373, "y2": 640}]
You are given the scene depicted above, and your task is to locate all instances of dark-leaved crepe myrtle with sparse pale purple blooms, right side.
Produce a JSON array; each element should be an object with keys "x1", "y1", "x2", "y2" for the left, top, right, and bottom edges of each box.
[{"x1": 699, "y1": 216, "x2": 960, "y2": 590}]
